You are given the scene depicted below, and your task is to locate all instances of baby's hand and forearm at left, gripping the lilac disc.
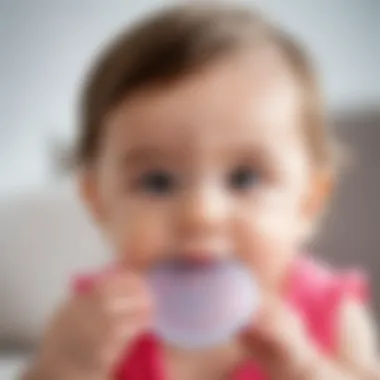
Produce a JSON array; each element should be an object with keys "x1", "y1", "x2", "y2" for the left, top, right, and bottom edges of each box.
[{"x1": 22, "y1": 273, "x2": 151, "y2": 380}]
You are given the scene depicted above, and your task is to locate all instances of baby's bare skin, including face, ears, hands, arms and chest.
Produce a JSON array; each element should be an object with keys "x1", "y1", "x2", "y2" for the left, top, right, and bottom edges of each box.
[{"x1": 24, "y1": 49, "x2": 380, "y2": 380}]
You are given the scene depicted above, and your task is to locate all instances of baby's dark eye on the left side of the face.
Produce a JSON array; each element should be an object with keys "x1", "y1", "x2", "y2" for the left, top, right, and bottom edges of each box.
[{"x1": 140, "y1": 170, "x2": 177, "y2": 195}]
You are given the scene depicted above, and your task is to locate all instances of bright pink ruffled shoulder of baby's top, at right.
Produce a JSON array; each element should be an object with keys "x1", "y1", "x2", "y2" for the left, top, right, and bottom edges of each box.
[{"x1": 286, "y1": 257, "x2": 369, "y2": 355}]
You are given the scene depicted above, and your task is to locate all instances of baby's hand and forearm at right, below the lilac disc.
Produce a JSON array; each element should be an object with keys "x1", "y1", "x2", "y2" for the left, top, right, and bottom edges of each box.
[{"x1": 243, "y1": 300, "x2": 357, "y2": 380}]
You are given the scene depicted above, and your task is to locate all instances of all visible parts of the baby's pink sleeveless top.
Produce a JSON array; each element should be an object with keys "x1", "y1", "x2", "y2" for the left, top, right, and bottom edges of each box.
[{"x1": 75, "y1": 258, "x2": 367, "y2": 380}]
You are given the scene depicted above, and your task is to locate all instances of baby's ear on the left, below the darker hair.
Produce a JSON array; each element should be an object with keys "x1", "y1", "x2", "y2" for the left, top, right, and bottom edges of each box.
[{"x1": 78, "y1": 169, "x2": 105, "y2": 224}]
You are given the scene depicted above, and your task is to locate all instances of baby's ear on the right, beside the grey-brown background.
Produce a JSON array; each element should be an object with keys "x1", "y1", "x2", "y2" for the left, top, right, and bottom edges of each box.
[{"x1": 303, "y1": 169, "x2": 334, "y2": 220}]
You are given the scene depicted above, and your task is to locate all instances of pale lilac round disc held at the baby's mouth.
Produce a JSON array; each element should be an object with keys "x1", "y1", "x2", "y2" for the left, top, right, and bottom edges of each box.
[{"x1": 149, "y1": 260, "x2": 259, "y2": 348}]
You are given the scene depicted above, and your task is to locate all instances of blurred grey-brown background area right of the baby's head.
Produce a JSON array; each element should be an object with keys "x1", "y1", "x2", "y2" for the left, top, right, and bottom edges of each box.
[{"x1": 313, "y1": 109, "x2": 380, "y2": 322}]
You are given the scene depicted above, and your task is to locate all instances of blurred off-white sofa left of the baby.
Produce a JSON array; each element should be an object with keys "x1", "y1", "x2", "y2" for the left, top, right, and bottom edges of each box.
[{"x1": 0, "y1": 186, "x2": 106, "y2": 348}]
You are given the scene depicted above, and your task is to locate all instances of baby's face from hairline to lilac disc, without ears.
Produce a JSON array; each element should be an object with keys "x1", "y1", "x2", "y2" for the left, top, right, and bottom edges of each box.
[{"x1": 90, "y1": 51, "x2": 310, "y2": 290}]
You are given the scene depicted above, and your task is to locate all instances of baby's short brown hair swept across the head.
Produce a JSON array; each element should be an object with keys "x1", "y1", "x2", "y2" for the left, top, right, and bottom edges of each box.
[{"x1": 77, "y1": 4, "x2": 330, "y2": 170}]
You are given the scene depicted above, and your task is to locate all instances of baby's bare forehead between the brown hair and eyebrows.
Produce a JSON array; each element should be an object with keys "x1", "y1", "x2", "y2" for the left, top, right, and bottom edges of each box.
[{"x1": 107, "y1": 54, "x2": 302, "y2": 148}]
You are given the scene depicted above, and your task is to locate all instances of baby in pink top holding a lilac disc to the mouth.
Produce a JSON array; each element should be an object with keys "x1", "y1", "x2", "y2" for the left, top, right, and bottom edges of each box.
[{"x1": 24, "y1": 4, "x2": 380, "y2": 380}]
